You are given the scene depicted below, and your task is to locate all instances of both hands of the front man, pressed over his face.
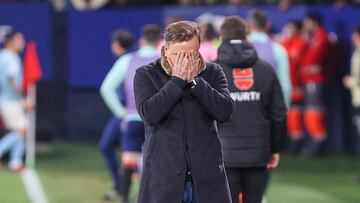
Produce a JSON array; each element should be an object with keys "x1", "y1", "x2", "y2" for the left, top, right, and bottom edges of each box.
[{"x1": 169, "y1": 51, "x2": 200, "y2": 82}]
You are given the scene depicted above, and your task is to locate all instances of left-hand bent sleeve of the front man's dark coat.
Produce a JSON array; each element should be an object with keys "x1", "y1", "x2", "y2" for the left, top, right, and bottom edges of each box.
[{"x1": 134, "y1": 68, "x2": 184, "y2": 125}]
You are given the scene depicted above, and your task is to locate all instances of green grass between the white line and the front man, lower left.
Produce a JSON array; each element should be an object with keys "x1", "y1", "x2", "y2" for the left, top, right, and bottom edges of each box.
[{"x1": 37, "y1": 143, "x2": 111, "y2": 203}]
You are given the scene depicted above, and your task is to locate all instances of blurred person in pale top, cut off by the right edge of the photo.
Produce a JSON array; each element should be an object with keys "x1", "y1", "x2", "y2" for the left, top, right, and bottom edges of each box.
[{"x1": 343, "y1": 25, "x2": 360, "y2": 136}]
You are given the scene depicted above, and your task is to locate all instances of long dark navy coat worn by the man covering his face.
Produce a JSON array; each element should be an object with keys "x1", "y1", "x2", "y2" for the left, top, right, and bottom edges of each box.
[{"x1": 134, "y1": 53, "x2": 234, "y2": 203}]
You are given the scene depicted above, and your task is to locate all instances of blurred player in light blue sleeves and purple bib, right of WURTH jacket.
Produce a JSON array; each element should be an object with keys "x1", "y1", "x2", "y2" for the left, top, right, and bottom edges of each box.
[{"x1": 248, "y1": 10, "x2": 291, "y2": 107}]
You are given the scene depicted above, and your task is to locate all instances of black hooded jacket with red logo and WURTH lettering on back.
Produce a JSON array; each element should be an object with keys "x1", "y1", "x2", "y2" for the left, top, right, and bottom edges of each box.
[{"x1": 217, "y1": 40, "x2": 287, "y2": 168}]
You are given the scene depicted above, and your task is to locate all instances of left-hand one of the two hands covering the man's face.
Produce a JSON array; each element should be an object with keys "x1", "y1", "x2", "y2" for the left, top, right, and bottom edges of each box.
[{"x1": 169, "y1": 51, "x2": 189, "y2": 81}]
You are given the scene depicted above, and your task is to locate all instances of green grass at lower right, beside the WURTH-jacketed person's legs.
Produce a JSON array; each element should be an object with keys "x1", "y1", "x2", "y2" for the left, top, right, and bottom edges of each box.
[{"x1": 269, "y1": 156, "x2": 360, "y2": 203}]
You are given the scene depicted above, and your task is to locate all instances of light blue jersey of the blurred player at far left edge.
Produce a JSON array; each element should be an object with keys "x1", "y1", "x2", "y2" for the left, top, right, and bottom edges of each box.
[{"x1": 0, "y1": 49, "x2": 22, "y2": 102}]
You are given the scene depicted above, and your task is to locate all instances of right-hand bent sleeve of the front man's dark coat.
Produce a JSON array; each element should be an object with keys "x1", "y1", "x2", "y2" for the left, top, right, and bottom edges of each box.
[{"x1": 191, "y1": 66, "x2": 234, "y2": 123}]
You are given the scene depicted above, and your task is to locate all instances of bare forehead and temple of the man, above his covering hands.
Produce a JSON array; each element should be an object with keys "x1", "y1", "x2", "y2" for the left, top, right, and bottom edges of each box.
[{"x1": 165, "y1": 36, "x2": 200, "y2": 64}]
